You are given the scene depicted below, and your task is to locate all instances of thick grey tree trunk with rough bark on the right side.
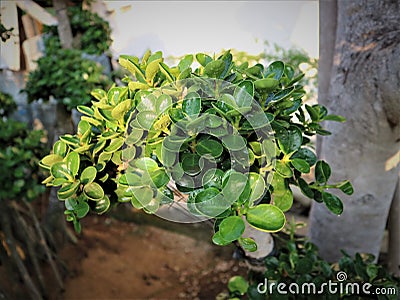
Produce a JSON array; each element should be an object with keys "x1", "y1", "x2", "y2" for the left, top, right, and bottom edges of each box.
[{"x1": 310, "y1": 0, "x2": 400, "y2": 261}]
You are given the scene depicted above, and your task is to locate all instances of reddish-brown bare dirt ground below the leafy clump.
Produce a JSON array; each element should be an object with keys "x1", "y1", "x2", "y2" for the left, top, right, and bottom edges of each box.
[{"x1": 50, "y1": 211, "x2": 246, "y2": 299}]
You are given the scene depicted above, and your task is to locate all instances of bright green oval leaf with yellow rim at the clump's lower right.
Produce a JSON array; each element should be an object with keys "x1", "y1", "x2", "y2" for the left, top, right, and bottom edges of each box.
[{"x1": 246, "y1": 204, "x2": 286, "y2": 232}]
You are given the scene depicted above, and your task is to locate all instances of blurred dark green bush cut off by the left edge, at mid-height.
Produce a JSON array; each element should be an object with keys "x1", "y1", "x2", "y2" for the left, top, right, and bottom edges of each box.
[{"x1": 0, "y1": 92, "x2": 45, "y2": 201}]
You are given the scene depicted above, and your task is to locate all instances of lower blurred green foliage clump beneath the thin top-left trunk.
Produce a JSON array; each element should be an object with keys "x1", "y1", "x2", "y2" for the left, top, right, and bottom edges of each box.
[{"x1": 24, "y1": 49, "x2": 109, "y2": 109}]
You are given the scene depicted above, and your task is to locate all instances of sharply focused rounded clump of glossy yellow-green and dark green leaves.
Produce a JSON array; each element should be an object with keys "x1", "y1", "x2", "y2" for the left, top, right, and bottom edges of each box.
[{"x1": 41, "y1": 51, "x2": 353, "y2": 251}]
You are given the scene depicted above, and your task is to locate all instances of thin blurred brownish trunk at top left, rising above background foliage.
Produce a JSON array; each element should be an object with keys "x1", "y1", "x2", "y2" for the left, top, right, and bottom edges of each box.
[{"x1": 53, "y1": 0, "x2": 73, "y2": 49}]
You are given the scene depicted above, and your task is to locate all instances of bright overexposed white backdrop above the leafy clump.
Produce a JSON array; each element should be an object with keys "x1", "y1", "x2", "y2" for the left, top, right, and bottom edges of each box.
[{"x1": 105, "y1": 0, "x2": 318, "y2": 57}]
